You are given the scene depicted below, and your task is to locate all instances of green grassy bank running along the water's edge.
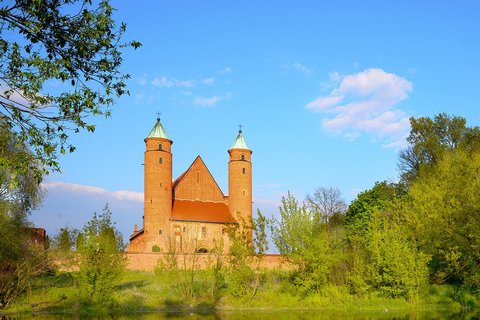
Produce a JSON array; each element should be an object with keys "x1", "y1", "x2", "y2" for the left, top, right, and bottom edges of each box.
[{"x1": 0, "y1": 271, "x2": 480, "y2": 314}]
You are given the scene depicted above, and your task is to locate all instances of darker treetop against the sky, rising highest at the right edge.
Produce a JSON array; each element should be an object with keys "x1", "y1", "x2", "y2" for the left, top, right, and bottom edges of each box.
[{"x1": 398, "y1": 113, "x2": 480, "y2": 182}]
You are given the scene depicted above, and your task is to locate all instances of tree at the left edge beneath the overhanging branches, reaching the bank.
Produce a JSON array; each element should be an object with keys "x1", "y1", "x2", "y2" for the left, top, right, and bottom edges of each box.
[{"x1": 0, "y1": 119, "x2": 45, "y2": 307}]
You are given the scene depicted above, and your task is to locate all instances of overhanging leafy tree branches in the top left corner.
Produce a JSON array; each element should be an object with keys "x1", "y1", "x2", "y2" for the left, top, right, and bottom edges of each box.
[{"x1": 0, "y1": 0, "x2": 140, "y2": 180}]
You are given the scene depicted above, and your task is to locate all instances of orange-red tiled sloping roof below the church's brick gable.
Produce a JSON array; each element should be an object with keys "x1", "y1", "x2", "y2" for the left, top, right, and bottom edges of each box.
[{"x1": 171, "y1": 200, "x2": 237, "y2": 223}]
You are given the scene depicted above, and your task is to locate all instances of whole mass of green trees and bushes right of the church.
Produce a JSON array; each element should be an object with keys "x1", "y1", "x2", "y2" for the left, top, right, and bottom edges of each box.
[{"x1": 264, "y1": 113, "x2": 480, "y2": 300}]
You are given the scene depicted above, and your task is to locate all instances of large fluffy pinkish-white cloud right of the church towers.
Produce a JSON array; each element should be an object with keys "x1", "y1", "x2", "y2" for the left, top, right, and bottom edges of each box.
[{"x1": 306, "y1": 69, "x2": 413, "y2": 147}]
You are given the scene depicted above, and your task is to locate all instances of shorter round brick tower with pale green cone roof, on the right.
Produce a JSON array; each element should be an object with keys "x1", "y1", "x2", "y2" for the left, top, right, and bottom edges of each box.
[{"x1": 228, "y1": 127, "x2": 252, "y2": 225}]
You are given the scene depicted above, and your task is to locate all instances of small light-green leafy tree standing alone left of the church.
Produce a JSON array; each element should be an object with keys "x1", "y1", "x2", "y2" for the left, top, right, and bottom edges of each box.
[{"x1": 76, "y1": 204, "x2": 126, "y2": 301}]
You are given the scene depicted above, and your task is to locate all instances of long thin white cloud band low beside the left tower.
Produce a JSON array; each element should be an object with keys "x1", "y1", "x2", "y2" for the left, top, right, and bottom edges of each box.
[{"x1": 42, "y1": 181, "x2": 143, "y2": 201}]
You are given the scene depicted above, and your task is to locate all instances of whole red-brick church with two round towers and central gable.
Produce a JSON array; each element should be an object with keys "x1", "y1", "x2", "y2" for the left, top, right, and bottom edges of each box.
[{"x1": 127, "y1": 119, "x2": 252, "y2": 252}]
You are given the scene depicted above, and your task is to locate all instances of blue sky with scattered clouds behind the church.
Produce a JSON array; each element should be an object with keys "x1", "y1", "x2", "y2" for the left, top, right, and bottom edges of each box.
[{"x1": 31, "y1": 1, "x2": 480, "y2": 245}]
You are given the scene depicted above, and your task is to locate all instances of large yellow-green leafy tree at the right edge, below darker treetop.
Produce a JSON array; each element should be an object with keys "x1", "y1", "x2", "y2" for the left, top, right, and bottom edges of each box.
[{"x1": 405, "y1": 149, "x2": 480, "y2": 288}]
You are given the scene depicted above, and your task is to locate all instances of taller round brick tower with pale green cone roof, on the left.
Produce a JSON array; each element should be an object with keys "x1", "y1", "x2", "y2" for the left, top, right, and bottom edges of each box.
[{"x1": 143, "y1": 118, "x2": 173, "y2": 251}]
